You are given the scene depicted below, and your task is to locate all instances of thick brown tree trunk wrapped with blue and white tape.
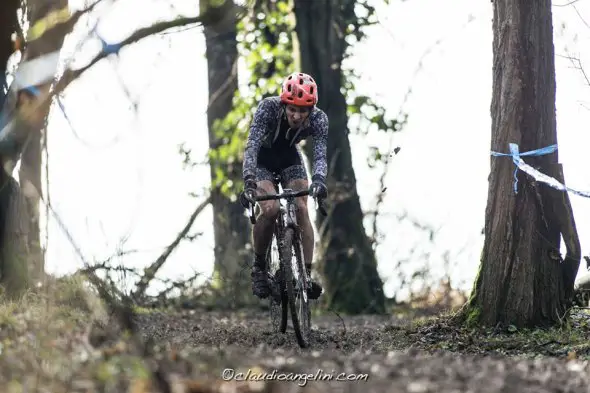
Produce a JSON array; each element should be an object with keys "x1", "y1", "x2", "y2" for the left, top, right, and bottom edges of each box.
[{"x1": 467, "y1": 0, "x2": 580, "y2": 327}]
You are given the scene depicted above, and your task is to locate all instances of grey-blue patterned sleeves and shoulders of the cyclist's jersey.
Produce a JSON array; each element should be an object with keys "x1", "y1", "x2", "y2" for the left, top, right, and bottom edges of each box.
[{"x1": 243, "y1": 96, "x2": 328, "y2": 179}]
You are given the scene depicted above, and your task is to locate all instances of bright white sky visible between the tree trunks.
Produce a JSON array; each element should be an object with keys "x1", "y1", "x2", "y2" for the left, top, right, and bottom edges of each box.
[{"x1": 27, "y1": 0, "x2": 590, "y2": 295}]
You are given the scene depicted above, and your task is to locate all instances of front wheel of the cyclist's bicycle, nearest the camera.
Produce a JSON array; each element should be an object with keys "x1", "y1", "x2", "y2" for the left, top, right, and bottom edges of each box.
[{"x1": 281, "y1": 228, "x2": 311, "y2": 348}]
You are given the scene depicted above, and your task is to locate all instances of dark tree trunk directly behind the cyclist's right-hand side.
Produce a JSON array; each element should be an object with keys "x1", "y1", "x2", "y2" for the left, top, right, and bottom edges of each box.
[{"x1": 295, "y1": 0, "x2": 385, "y2": 314}]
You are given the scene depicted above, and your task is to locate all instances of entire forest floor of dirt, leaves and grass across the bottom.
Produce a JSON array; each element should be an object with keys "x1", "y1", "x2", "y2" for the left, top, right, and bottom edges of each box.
[{"x1": 0, "y1": 280, "x2": 590, "y2": 393}]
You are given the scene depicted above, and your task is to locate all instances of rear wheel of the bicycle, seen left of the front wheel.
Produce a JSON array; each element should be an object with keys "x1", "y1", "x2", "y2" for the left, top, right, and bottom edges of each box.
[{"x1": 266, "y1": 231, "x2": 288, "y2": 333}]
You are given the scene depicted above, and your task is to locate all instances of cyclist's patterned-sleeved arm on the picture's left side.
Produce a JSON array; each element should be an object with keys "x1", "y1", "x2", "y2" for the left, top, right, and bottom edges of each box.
[{"x1": 242, "y1": 99, "x2": 276, "y2": 179}]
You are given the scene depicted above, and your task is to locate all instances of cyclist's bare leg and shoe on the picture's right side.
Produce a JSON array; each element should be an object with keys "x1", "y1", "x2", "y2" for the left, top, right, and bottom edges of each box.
[{"x1": 282, "y1": 165, "x2": 322, "y2": 299}]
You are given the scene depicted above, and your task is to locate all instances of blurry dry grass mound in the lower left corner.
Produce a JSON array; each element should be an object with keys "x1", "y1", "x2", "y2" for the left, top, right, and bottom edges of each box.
[{"x1": 0, "y1": 277, "x2": 148, "y2": 393}]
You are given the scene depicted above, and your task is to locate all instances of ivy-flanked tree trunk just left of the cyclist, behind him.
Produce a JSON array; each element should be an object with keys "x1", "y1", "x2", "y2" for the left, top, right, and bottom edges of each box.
[{"x1": 201, "y1": 0, "x2": 252, "y2": 306}]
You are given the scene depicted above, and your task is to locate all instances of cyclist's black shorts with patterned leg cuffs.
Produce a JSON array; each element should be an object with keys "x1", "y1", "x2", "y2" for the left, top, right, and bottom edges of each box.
[{"x1": 256, "y1": 146, "x2": 308, "y2": 187}]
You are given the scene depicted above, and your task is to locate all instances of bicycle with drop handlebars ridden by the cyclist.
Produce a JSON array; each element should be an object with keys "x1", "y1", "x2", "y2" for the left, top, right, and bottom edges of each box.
[{"x1": 249, "y1": 176, "x2": 327, "y2": 348}]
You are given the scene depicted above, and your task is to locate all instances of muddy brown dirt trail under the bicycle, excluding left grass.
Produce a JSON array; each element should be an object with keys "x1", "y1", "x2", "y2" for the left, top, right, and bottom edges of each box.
[{"x1": 132, "y1": 311, "x2": 590, "y2": 393}]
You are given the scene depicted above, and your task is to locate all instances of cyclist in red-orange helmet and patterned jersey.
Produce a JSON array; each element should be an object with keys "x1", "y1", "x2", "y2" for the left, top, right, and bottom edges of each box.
[{"x1": 241, "y1": 72, "x2": 328, "y2": 299}]
